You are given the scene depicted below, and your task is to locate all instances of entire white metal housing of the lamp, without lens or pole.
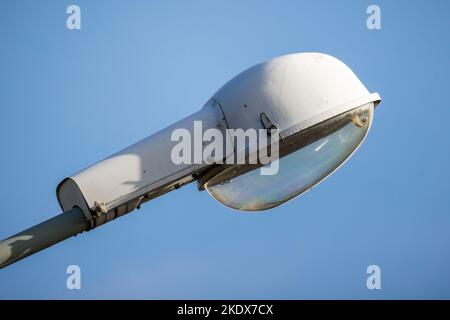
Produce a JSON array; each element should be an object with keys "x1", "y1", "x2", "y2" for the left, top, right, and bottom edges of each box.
[{"x1": 57, "y1": 53, "x2": 380, "y2": 227}]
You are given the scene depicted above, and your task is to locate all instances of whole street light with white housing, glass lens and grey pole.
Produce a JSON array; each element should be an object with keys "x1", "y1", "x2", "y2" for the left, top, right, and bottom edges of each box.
[{"x1": 0, "y1": 53, "x2": 380, "y2": 267}]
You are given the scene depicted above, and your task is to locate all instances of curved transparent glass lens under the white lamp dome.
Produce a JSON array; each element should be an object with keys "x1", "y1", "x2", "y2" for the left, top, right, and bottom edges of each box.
[{"x1": 205, "y1": 103, "x2": 373, "y2": 211}]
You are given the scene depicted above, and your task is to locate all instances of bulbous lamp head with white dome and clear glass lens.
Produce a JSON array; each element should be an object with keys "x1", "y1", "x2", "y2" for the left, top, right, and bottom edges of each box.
[{"x1": 199, "y1": 53, "x2": 380, "y2": 211}]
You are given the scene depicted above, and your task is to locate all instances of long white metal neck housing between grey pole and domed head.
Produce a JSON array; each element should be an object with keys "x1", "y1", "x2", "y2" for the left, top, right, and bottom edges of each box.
[{"x1": 57, "y1": 104, "x2": 230, "y2": 226}]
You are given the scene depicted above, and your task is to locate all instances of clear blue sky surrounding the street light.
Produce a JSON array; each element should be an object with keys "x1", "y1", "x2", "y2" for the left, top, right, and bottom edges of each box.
[{"x1": 0, "y1": 0, "x2": 450, "y2": 299}]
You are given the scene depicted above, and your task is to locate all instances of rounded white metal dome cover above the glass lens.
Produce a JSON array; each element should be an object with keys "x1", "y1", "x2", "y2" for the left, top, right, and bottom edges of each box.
[{"x1": 213, "y1": 53, "x2": 380, "y2": 145}]
